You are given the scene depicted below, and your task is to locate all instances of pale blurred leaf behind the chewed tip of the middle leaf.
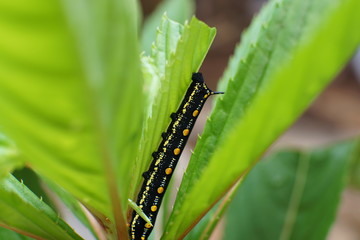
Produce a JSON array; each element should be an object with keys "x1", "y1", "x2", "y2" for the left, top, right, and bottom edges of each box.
[{"x1": 141, "y1": 0, "x2": 194, "y2": 53}]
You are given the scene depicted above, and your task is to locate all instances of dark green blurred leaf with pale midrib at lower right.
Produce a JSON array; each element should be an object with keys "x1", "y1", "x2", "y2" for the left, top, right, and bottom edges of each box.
[{"x1": 224, "y1": 142, "x2": 355, "y2": 240}]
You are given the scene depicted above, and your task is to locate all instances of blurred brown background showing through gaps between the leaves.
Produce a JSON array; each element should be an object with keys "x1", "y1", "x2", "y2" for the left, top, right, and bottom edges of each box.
[{"x1": 142, "y1": 0, "x2": 360, "y2": 240}]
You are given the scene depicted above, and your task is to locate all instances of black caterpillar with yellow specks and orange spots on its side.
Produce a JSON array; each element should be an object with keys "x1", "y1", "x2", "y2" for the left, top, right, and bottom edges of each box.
[{"x1": 129, "y1": 72, "x2": 223, "y2": 240}]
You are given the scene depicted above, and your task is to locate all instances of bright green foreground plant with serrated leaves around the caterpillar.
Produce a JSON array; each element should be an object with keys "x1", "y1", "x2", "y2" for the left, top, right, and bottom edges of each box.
[{"x1": 0, "y1": 0, "x2": 360, "y2": 239}]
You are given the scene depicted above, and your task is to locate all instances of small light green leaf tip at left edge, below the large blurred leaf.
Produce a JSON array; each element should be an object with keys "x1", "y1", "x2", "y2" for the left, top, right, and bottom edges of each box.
[{"x1": 0, "y1": 133, "x2": 24, "y2": 179}]
